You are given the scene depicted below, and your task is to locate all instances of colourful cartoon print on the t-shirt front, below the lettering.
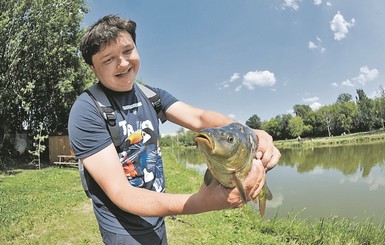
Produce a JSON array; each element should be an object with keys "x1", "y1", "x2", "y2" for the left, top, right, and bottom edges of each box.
[{"x1": 119, "y1": 128, "x2": 164, "y2": 192}]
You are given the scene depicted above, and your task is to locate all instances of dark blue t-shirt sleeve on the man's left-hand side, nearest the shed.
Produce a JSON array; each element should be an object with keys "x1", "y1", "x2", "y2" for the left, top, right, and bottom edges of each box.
[{"x1": 68, "y1": 93, "x2": 112, "y2": 159}]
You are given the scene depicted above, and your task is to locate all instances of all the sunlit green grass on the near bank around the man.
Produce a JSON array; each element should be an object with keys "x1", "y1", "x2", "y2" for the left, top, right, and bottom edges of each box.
[{"x1": 0, "y1": 149, "x2": 385, "y2": 244}]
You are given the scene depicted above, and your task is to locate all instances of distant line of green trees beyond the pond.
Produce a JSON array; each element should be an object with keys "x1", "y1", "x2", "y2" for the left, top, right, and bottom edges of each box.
[{"x1": 246, "y1": 87, "x2": 385, "y2": 139}]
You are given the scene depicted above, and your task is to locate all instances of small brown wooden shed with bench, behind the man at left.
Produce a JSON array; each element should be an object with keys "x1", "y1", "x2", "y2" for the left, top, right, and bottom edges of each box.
[{"x1": 48, "y1": 135, "x2": 77, "y2": 166}]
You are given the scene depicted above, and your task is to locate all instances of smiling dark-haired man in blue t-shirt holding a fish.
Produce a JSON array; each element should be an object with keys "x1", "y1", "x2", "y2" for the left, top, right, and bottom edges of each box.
[{"x1": 68, "y1": 15, "x2": 280, "y2": 244}]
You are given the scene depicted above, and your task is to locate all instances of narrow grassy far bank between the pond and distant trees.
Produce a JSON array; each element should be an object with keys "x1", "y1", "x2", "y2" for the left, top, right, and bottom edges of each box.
[{"x1": 274, "y1": 130, "x2": 385, "y2": 149}]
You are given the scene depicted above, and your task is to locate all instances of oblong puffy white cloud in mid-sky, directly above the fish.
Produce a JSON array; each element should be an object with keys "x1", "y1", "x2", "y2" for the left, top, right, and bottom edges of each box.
[{"x1": 242, "y1": 70, "x2": 276, "y2": 90}]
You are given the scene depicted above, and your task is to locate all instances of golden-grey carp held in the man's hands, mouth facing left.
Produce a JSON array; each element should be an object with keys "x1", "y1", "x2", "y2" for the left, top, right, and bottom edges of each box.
[{"x1": 194, "y1": 122, "x2": 273, "y2": 216}]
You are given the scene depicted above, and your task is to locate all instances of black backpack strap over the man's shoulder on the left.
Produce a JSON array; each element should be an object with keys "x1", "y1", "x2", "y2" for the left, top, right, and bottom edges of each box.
[{"x1": 85, "y1": 83, "x2": 122, "y2": 147}]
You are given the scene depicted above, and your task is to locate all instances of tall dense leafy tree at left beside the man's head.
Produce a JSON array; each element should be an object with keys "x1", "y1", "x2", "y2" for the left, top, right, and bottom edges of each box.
[{"x1": 0, "y1": 0, "x2": 93, "y2": 162}]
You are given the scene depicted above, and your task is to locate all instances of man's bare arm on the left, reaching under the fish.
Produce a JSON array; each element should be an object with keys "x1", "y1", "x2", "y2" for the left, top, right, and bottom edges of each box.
[{"x1": 82, "y1": 144, "x2": 264, "y2": 216}]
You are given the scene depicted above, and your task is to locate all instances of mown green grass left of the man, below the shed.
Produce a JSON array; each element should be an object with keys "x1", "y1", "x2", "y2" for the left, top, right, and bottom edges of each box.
[{"x1": 0, "y1": 168, "x2": 101, "y2": 244}]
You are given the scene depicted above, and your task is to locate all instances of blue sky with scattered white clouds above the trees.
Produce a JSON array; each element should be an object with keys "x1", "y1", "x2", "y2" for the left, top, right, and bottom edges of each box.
[{"x1": 82, "y1": 0, "x2": 385, "y2": 133}]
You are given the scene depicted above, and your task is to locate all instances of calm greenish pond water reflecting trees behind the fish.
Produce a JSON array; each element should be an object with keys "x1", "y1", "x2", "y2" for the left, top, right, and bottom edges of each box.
[{"x1": 172, "y1": 143, "x2": 385, "y2": 224}]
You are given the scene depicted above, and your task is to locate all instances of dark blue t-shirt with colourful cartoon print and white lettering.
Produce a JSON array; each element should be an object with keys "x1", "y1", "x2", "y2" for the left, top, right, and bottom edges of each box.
[{"x1": 68, "y1": 84, "x2": 177, "y2": 235}]
